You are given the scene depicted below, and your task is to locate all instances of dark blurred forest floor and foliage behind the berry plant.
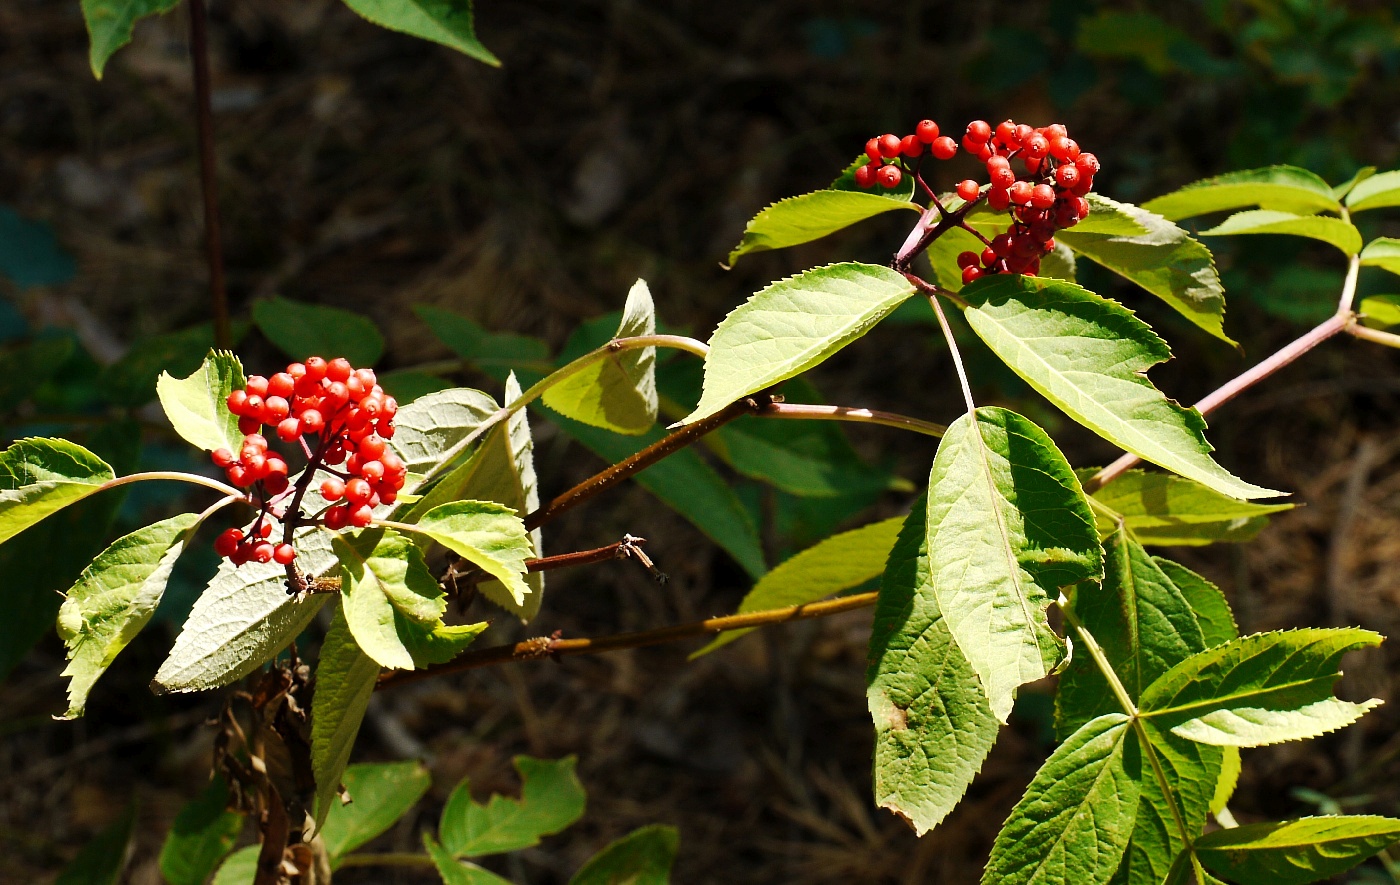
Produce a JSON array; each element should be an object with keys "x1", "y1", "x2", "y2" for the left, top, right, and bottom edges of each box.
[{"x1": 0, "y1": 0, "x2": 1400, "y2": 882}]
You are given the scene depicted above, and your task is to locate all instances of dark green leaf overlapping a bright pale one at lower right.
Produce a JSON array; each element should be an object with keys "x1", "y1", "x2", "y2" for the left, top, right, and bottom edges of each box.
[{"x1": 1140, "y1": 629, "x2": 1382, "y2": 730}]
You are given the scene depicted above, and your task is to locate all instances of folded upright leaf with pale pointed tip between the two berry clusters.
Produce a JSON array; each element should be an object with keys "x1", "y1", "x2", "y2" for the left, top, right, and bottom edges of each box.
[{"x1": 543, "y1": 280, "x2": 657, "y2": 435}]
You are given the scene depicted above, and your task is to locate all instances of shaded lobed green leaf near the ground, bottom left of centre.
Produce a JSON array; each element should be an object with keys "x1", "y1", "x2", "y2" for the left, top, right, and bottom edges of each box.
[{"x1": 438, "y1": 756, "x2": 585, "y2": 857}]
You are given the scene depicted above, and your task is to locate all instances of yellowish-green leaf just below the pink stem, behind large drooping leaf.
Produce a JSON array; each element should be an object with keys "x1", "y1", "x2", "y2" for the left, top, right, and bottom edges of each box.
[{"x1": 1081, "y1": 471, "x2": 1292, "y2": 546}]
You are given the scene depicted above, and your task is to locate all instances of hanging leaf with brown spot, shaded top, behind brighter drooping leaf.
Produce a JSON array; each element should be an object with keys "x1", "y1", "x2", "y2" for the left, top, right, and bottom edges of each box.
[{"x1": 865, "y1": 500, "x2": 998, "y2": 836}]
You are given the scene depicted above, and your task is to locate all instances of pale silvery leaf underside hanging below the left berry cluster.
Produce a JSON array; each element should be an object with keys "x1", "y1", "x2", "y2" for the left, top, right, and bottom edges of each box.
[{"x1": 151, "y1": 529, "x2": 337, "y2": 693}]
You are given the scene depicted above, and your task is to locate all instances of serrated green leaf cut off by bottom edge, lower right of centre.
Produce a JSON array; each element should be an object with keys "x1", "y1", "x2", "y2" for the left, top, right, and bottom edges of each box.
[{"x1": 981, "y1": 713, "x2": 1142, "y2": 885}]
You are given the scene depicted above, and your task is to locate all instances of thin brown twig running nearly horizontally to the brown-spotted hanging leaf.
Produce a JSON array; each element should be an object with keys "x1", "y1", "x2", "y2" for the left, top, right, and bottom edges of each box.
[{"x1": 375, "y1": 591, "x2": 879, "y2": 689}]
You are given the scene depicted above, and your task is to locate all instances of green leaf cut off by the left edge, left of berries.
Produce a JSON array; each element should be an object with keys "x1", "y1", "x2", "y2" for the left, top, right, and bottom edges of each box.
[{"x1": 0, "y1": 437, "x2": 115, "y2": 543}]
